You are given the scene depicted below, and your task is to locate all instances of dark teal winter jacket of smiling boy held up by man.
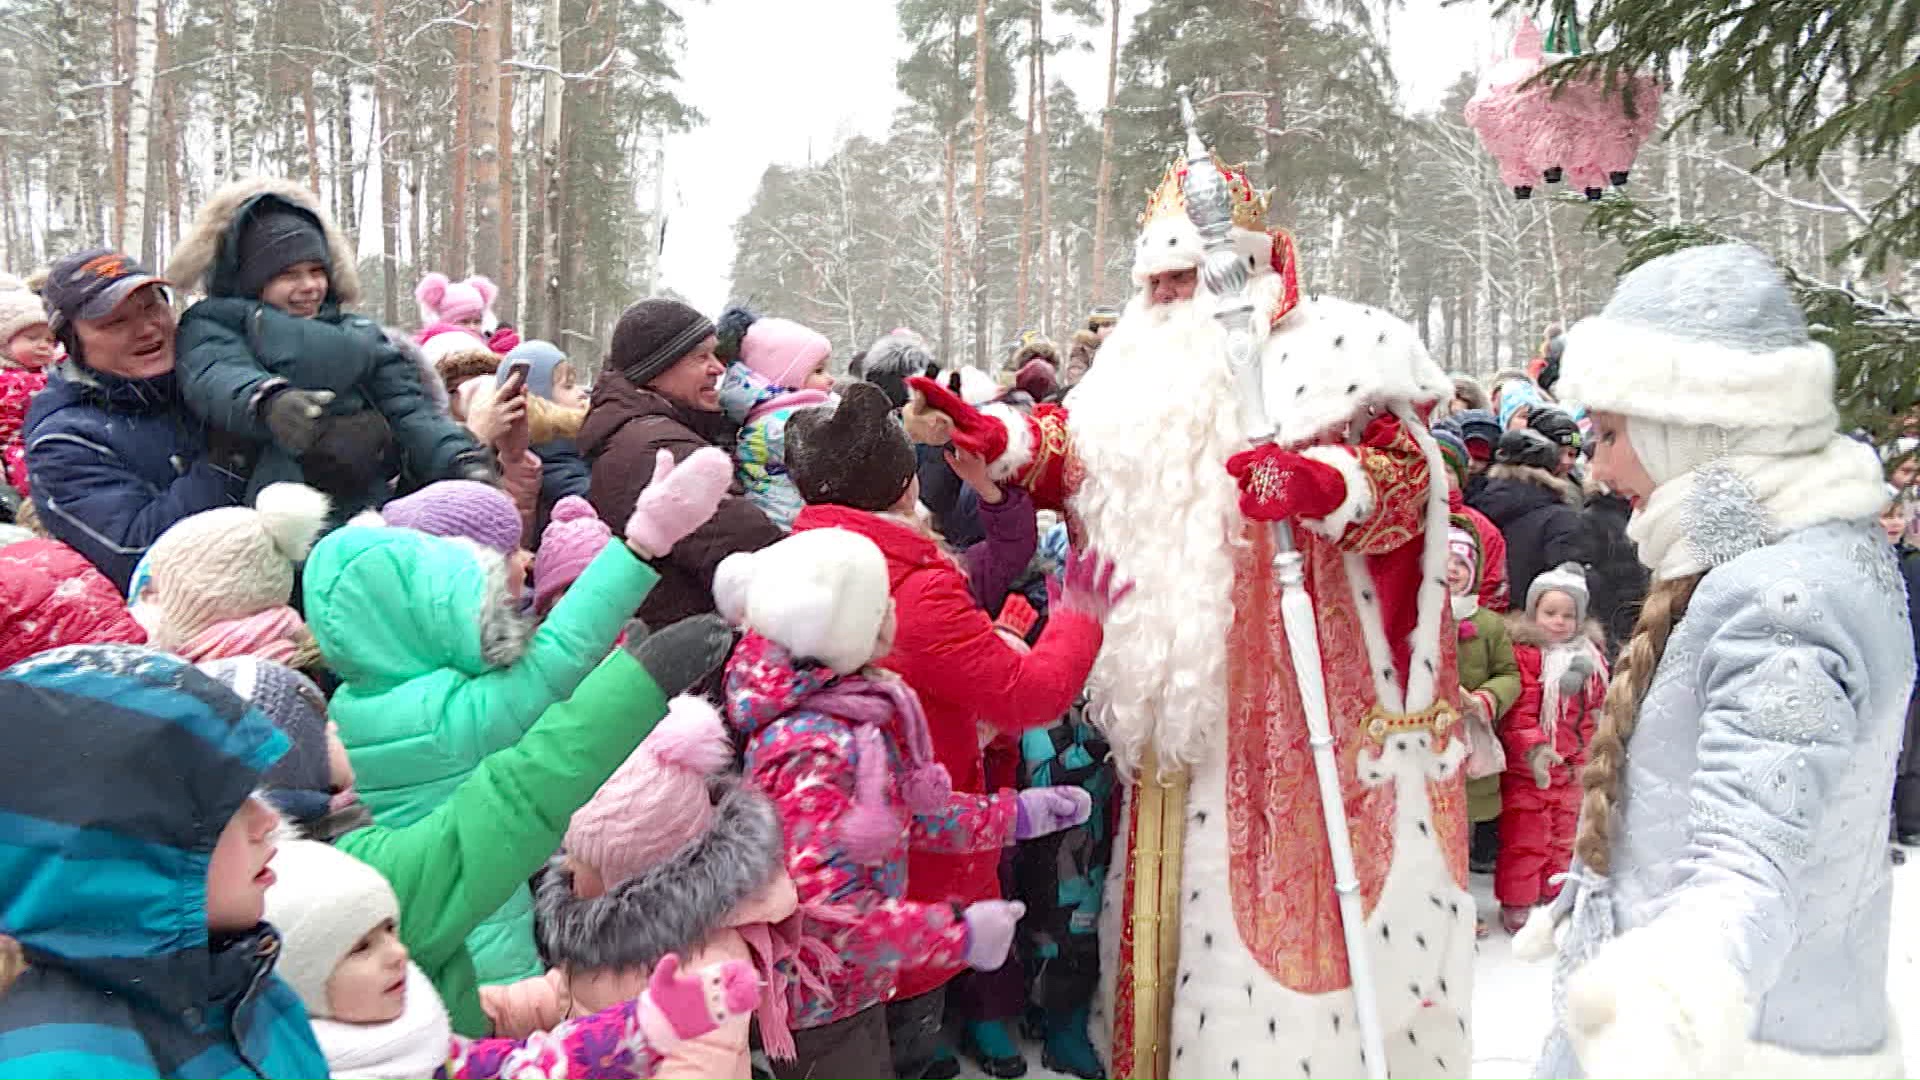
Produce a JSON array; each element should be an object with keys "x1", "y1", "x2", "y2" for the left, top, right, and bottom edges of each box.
[{"x1": 175, "y1": 194, "x2": 480, "y2": 521}]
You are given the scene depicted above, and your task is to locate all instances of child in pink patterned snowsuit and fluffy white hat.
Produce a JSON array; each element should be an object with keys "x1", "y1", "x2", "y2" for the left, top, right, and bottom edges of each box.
[{"x1": 714, "y1": 528, "x2": 1091, "y2": 1080}]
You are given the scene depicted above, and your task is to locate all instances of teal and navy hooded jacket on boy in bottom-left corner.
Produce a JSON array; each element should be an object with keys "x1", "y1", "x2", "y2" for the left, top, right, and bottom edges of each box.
[{"x1": 0, "y1": 646, "x2": 326, "y2": 1080}]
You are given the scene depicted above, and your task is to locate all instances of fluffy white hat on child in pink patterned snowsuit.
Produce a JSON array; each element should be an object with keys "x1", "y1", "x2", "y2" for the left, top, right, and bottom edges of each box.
[{"x1": 714, "y1": 528, "x2": 893, "y2": 675}]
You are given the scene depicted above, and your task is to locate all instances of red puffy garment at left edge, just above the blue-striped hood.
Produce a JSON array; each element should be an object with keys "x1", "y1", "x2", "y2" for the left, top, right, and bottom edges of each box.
[{"x1": 0, "y1": 540, "x2": 146, "y2": 667}]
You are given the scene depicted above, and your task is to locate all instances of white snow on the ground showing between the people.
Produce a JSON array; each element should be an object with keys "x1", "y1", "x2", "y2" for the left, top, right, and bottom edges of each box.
[{"x1": 975, "y1": 851, "x2": 1920, "y2": 1080}]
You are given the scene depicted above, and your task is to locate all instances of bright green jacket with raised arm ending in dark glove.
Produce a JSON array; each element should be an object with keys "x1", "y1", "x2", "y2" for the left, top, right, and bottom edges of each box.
[{"x1": 336, "y1": 650, "x2": 666, "y2": 1038}]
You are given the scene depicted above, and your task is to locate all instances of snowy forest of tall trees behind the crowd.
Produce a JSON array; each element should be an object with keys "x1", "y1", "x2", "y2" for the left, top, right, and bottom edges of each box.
[{"x1": 0, "y1": 0, "x2": 1920, "y2": 417}]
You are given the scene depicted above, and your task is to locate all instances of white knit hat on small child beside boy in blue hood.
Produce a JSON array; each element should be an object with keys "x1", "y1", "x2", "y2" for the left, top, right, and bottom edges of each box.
[{"x1": 267, "y1": 840, "x2": 399, "y2": 1020}]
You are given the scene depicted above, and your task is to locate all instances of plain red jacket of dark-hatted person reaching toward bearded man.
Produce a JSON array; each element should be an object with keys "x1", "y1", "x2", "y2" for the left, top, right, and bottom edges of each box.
[{"x1": 793, "y1": 505, "x2": 1100, "y2": 997}]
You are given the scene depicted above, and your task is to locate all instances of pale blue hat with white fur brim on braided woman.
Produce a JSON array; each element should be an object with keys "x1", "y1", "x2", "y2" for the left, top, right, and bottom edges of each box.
[{"x1": 1555, "y1": 244, "x2": 1837, "y2": 432}]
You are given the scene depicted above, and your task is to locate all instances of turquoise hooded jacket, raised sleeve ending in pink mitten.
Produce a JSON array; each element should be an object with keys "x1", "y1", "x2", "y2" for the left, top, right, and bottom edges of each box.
[{"x1": 305, "y1": 525, "x2": 659, "y2": 984}]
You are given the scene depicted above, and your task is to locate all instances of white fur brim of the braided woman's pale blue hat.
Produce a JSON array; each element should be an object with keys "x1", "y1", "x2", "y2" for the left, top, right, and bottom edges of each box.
[{"x1": 1555, "y1": 315, "x2": 1837, "y2": 430}]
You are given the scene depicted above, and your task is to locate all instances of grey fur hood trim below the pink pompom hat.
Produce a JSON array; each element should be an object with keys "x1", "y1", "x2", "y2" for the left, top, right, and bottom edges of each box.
[{"x1": 534, "y1": 778, "x2": 791, "y2": 972}]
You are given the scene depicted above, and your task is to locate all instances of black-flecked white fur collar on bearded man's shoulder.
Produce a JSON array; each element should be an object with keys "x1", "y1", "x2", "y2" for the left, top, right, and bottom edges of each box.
[{"x1": 1260, "y1": 296, "x2": 1453, "y2": 446}]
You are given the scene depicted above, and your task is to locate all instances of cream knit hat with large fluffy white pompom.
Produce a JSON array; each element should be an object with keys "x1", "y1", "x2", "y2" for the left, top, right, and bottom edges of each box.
[{"x1": 140, "y1": 484, "x2": 328, "y2": 650}]
